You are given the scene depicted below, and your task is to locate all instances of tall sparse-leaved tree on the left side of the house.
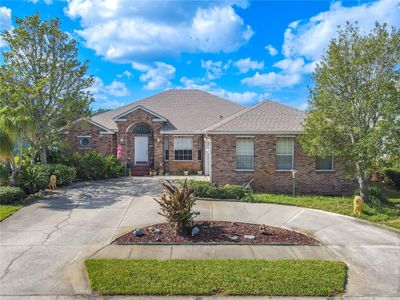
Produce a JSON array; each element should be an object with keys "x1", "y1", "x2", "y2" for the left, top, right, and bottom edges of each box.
[{"x1": 0, "y1": 14, "x2": 93, "y2": 163}]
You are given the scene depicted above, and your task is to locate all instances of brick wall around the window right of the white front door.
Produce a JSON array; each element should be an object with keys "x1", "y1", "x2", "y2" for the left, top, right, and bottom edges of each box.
[{"x1": 164, "y1": 135, "x2": 204, "y2": 174}]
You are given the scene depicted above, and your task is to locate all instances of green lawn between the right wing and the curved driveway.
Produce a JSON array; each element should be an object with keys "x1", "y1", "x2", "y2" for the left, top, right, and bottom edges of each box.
[{"x1": 254, "y1": 190, "x2": 400, "y2": 229}]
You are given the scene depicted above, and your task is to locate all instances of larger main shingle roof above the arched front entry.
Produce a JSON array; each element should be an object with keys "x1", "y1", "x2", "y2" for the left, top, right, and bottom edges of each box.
[{"x1": 92, "y1": 89, "x2": 244, "y2": 132}]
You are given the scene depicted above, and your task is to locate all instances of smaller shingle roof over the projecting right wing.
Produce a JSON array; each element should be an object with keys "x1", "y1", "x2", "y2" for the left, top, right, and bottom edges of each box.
[{"x1": 206, "y1": 100, "x2": 306, "y2": 133}]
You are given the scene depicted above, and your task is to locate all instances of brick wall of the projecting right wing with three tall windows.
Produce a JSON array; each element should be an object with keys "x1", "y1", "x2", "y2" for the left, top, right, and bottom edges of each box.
[{"x1": 211, "y1": 135, "x2": 356, "y2": 195}]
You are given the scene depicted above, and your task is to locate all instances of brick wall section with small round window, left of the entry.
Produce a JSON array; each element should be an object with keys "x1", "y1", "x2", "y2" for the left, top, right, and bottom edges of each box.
[{"x1": 65, "y1": 120, "x2": 116, "y2": 155}]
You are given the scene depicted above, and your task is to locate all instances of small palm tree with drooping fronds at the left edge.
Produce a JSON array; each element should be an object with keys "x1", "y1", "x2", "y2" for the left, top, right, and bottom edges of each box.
[{"x1": 0, "y1": 106, "x2": 33, "y2": 185}]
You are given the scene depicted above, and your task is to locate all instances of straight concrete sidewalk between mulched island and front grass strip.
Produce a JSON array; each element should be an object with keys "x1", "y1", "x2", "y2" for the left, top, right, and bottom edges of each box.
[{"x1": 90, "y1": 244, "x2": 340, "y2": 260}]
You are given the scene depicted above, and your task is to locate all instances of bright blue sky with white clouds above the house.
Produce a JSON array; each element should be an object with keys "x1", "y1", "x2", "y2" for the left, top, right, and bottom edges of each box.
[{"x1": 0, "y1": 0, "x2": 400, "y2": 109}]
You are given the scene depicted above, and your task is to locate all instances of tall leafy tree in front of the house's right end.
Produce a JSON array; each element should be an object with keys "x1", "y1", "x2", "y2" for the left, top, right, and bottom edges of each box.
[{"x1": 300, "y1": 23, "x2": 400, "y2": 201}]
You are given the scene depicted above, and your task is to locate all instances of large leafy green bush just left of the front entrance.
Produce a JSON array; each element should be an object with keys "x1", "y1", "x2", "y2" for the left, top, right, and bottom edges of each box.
[{"x1": 72, "y1": 151, "x2": 124, "y2": 180}]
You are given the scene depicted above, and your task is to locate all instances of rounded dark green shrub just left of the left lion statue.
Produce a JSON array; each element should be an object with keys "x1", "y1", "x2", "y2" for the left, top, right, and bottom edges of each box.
[{"x1": 17, "y1": 167, "x2": 49, "y2": 194}]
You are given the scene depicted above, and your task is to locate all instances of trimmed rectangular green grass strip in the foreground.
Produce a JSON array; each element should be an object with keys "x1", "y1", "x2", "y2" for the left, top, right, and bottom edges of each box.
[{"x1": 85, "y1": 259, "x2": 347, "y2": 296}]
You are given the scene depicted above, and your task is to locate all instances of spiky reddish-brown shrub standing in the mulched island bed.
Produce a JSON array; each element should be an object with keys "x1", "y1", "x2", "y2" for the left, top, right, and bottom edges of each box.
[{"x1": 154, "y1": 180, "x2": 199, "y2": 235}]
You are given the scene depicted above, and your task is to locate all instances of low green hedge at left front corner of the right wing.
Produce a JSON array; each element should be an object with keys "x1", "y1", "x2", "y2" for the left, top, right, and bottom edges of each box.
[{"x1": 178, "y1": 180, "x2": 252, "y2": 201}]
